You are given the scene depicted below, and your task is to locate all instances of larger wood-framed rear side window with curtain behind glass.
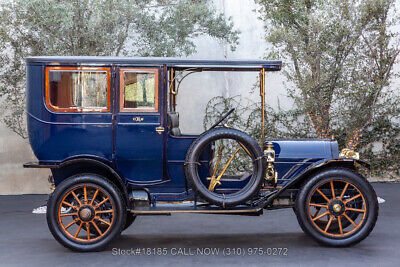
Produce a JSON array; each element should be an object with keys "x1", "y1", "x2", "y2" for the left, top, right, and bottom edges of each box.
[{"x1": 46, "y1": 67, "x2": 110, "y2": 112}]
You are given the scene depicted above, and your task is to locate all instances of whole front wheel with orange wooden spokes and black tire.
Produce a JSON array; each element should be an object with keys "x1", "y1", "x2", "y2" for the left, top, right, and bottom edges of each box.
[{"x1": 296, "y1": 168, "x2": 378, "y2": 247}]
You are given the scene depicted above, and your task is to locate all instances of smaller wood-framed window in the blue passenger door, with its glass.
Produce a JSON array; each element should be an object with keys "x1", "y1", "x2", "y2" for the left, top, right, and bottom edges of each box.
[{"x1": 120, "y1": 69, "x2": 158, "y2": 112}]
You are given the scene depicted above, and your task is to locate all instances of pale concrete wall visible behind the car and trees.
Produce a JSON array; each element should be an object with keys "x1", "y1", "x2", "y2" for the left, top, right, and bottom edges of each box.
[{"x1": 0, "y1": 0, "x2": 400, "y2": 194}]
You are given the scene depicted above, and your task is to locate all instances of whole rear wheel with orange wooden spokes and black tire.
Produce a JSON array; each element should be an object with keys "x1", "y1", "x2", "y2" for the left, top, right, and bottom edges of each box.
[{"x1": 47, "y1": 174, "x2": 126, "y2": 251}]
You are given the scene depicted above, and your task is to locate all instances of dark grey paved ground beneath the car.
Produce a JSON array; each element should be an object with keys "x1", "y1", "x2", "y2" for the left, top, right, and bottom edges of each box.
[{"x1": 0, "y1": 184, "x2": 400, "y2": 266}]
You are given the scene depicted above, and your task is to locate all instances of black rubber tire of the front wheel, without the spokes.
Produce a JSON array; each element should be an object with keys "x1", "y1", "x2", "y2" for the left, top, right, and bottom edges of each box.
[{"x1": 295, "y1": 168, "x2": 379, "y2": 247}]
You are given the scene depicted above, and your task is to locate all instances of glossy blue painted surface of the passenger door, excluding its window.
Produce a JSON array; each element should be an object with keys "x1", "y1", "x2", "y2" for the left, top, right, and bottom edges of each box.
[{"x1": 114, "y1": 66, "x2": 168, "y2": 185}]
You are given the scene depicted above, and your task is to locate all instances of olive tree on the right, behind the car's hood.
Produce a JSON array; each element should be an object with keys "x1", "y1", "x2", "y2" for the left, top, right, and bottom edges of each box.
[{"x1": 255, "y1": 0, "x2": 400, "y2": 178}]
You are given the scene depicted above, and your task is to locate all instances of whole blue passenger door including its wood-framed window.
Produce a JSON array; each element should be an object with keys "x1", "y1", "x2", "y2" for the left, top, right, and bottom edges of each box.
[{"x1": 115, "y1": 67, "x2": 165, "y2": 184}]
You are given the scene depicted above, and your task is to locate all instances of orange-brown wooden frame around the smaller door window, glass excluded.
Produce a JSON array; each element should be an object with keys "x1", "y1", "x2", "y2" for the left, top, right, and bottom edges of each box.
[{"x1": 119, "y1": 68, "x2": 159, "y2": 113}]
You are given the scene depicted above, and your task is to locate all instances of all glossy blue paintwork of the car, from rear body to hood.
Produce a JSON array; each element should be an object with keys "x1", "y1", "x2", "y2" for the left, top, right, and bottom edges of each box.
[{"x1": 26, "y1": 58, "x2": 339, "y2": 201}]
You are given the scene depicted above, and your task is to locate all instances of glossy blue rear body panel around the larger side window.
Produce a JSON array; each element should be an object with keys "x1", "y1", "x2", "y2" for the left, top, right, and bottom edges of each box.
[{"x1": 26, "y1": 64, "x2": 113, "y2": 162}]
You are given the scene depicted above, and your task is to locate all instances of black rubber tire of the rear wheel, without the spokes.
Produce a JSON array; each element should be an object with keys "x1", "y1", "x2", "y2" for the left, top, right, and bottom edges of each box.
[{"x1": 46, "y1": 174, "x2": 127, "y2": 252}]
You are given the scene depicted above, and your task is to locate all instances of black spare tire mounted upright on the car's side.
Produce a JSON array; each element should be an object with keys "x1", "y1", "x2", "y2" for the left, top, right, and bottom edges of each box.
[{"x1": 184, "y1": 127, "x2": 265, "y2": 208}]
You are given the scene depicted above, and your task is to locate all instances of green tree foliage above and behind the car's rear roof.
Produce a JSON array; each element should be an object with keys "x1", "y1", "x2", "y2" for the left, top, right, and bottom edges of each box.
[{"x1": 0, "y1": 0, "x2": 239, "y2": 138}]
